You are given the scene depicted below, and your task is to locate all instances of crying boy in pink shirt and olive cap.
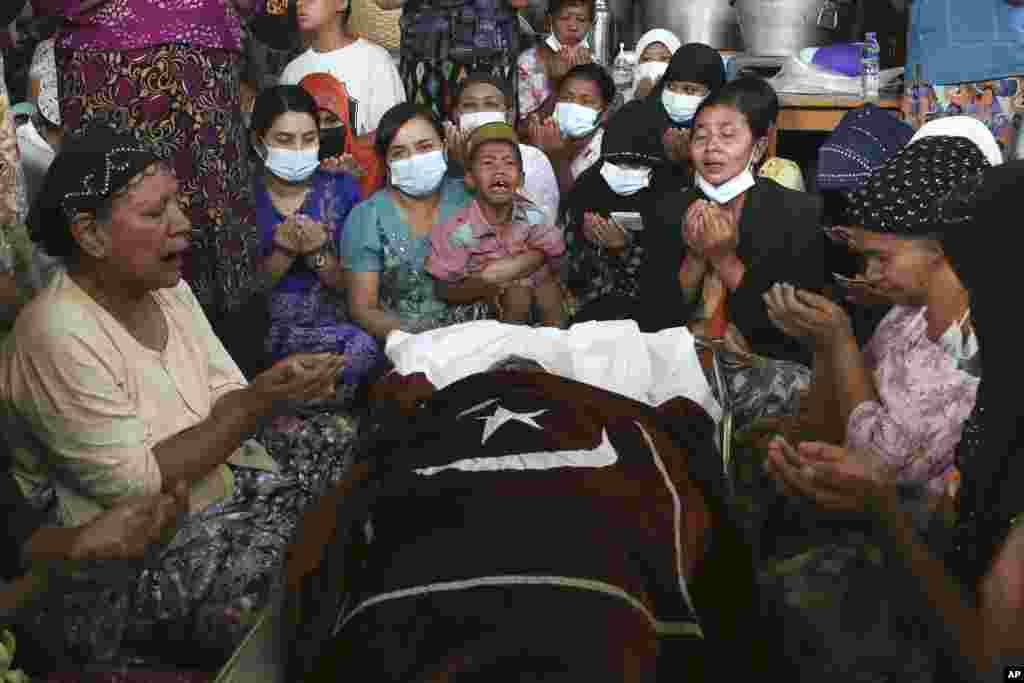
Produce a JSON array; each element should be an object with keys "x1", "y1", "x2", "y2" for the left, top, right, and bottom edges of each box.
[{"x1": 426, "y1": 122, "x2": 565, "y2": 328}]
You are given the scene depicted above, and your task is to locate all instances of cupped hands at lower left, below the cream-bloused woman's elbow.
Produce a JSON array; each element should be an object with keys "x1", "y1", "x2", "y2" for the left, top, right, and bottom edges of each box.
[{"x1": 69, "y1": 481, "x2": 188, "y2": 562}]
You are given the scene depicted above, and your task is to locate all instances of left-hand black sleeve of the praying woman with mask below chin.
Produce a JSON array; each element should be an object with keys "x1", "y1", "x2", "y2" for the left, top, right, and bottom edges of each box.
[{"x1": 637, "y1": 191, "x2": 696, "y2": 332}]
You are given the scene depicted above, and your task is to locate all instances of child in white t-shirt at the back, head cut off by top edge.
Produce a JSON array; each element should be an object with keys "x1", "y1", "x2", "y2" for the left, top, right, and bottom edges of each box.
[{"x1": 281, "y1": 0, "x2": 406, "y2": 135}]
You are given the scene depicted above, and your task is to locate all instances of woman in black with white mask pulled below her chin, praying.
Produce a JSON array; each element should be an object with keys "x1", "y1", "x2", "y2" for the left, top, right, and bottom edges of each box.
[{"x1": 637, "y1": 78, "x2": 825, "y2": 428}]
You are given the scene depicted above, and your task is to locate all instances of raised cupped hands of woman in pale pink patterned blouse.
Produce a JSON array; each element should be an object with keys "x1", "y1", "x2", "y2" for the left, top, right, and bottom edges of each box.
[{"x1": 764, "y1": 283, "x2": 853, "y2": 348}]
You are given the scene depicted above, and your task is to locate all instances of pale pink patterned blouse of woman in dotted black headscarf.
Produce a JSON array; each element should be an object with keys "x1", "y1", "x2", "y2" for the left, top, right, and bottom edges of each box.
[{"x1": 846, "y1": 306, "x2": 980, "y2": 493}]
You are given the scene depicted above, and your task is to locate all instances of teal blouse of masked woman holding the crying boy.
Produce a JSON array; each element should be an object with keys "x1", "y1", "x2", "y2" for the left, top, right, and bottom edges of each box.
[{"x1": 340, "y1": 177, "x2": 472, "y2": 329}]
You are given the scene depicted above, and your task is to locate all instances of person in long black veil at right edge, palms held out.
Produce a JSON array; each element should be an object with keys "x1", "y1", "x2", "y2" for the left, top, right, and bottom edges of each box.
[{"x1": 769, "y1": 162, "x2": 1024, "y2": 681}]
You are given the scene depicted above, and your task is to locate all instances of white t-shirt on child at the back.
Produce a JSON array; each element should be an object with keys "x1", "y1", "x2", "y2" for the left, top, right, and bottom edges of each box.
[{"x1": 281, "y1": 38, "x2": 406, "y2": 135}]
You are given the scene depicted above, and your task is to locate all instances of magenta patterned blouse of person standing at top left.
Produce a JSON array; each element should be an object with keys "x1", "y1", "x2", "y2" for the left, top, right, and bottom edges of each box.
[{"x1": 50, "y1": 0, "x2": 263, "y2": 52}]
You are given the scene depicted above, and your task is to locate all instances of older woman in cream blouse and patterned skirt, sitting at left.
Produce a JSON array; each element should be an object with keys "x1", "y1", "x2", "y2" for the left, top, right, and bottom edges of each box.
[{"x1": 0, "y1": 128, "x2": 342, "y2": 660}]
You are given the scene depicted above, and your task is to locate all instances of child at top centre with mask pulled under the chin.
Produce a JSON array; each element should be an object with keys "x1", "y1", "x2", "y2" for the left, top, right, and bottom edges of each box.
[{"x1": 517, "y1": 0, "x2": 594, "y2": 121}]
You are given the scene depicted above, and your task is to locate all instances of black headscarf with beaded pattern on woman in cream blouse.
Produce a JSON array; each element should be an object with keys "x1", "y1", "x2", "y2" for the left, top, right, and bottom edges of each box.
[{"x1": 28, "y1": 124, "x2": 160, "y2": 260}]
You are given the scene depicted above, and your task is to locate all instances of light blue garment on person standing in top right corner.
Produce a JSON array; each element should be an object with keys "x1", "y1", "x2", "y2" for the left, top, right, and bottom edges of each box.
[{"x1": 906, "y1": 0, "x2": 1024, "y2": 85}]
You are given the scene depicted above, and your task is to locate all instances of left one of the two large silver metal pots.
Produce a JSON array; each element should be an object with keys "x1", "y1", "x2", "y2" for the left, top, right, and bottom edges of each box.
[{"x1": 636, "y1": 0, "x2": 742, "y2": 50}]
